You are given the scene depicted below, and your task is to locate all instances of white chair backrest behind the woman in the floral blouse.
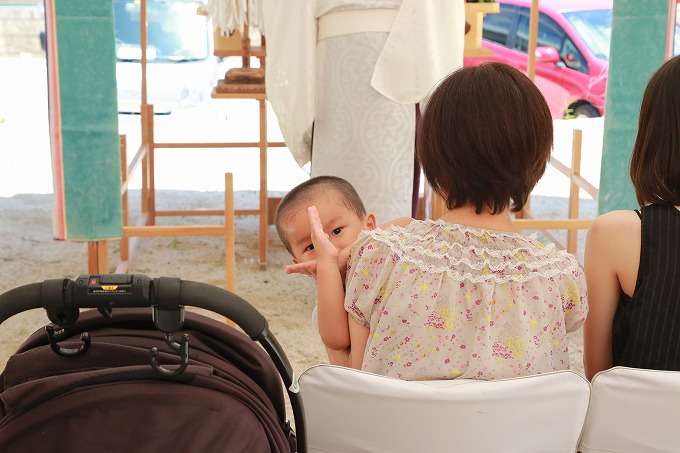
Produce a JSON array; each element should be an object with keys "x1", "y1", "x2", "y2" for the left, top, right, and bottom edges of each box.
[{"x1": 299, "y1": 365, "x2": 590, "y2": 453}]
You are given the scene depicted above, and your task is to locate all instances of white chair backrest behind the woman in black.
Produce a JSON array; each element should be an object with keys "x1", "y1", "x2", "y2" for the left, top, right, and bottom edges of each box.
[{"x1": 580, "y1": 367, "x2": 680, "y2": 453}]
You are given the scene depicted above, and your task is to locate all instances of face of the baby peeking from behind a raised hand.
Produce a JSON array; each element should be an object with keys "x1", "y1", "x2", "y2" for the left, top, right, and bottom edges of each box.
[{"x1": 289, "y1": 199, "x2": 375, "y2": 263}]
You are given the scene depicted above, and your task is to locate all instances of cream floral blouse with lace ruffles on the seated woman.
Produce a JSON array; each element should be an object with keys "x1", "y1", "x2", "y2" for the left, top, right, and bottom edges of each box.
[{"x1": 345, "y1": 220, "x2": 588, "y2": 380}]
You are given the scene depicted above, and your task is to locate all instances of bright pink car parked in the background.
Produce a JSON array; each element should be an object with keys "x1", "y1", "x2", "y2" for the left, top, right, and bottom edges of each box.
[{"x1": 464, "y1": 0, "x2": 613, "y2": 118}]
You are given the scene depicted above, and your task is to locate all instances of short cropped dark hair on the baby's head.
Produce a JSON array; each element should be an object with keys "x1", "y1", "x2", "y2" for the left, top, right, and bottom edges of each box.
[{"x1": 275, "y1": 176, "x2": 366, "y2": 255}]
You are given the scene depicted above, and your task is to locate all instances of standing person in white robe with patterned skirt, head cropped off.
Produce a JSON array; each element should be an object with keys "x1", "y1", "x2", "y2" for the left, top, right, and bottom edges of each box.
[{"x1": 261, "y1": 0, "x2": 465, "y2": 222}]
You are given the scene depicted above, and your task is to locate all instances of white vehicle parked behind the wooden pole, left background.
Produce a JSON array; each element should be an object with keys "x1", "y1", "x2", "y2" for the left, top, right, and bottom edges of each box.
[{"x1": 113, "y1": 0, "x2": 219, "y2": 114}]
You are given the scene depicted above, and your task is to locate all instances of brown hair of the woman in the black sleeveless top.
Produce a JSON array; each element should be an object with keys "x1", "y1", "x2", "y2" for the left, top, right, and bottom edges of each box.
[{"x1": 630, "y1": 53, "x2": 680, "y2": 206}]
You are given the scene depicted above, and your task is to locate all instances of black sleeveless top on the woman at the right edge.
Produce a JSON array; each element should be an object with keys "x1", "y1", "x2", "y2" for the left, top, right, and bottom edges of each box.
[{"x1": 612, "y1": 205, "x2": 680, "y2": 371}]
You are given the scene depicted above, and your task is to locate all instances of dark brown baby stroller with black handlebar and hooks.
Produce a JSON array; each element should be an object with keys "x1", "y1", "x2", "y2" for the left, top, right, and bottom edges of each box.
[{"x1": 0, "y1": 274, "x2": 306, "y2": 453}]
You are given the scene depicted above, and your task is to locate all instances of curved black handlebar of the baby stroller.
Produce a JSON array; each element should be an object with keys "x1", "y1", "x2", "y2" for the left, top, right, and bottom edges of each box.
[{"x1": 0, "y1": 274, "x2": 294, "y2": 386}]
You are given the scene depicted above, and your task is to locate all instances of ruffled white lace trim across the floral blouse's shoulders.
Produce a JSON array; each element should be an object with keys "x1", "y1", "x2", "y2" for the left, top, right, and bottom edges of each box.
[{"x1": 354, "y1": 220, "x2": 581, "y2": 283}]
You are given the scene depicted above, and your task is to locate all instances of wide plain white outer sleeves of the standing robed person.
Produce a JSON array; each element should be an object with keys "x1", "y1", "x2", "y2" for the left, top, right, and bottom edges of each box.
[{"x1": 263, "y1": 0, "x2": 465, "y2": 165}]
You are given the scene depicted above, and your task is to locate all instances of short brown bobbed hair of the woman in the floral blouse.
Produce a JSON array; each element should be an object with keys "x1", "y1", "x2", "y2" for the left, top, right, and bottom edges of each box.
[{"x1": 417, "y1": 63, "x2": 553, "y2": 214}]
